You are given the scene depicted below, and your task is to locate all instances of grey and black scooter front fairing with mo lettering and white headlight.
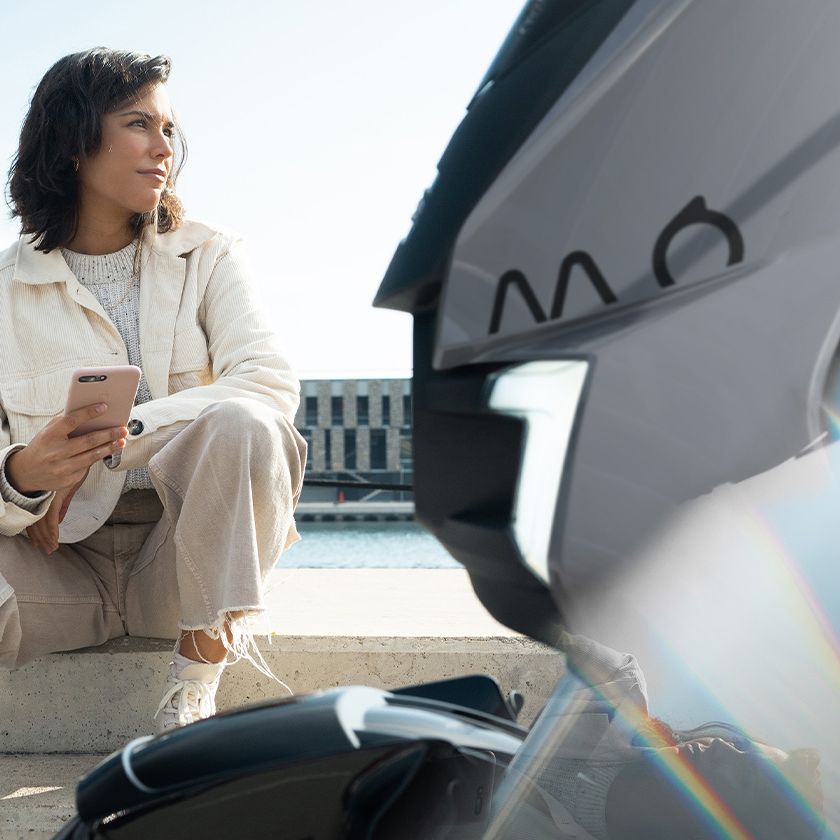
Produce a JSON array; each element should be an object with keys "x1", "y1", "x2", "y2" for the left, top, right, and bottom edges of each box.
[{"x1": 376, "y1": 0, "x2": 840, "y2": 837}]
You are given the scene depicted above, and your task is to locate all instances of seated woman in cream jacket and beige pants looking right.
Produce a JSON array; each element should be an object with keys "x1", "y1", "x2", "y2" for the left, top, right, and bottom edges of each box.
[{"x1": 0, "y1": 48, "x2": 306, "y2": 729}]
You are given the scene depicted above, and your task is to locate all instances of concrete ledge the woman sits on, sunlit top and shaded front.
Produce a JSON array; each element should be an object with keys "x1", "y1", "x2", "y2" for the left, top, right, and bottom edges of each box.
[{"x1": 0, "y1": 569, "x2": 563, "y2": 754}]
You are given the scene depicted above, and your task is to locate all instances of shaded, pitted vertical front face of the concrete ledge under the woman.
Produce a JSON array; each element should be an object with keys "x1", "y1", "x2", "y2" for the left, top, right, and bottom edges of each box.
[{"x1": 0, "y1": 636, "x2": 562, "y2": 753}]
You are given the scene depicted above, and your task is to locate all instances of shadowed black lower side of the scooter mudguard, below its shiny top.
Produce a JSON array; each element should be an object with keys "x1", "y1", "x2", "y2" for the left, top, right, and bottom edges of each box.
[{"x1": 58, "y1": 740, "x2": 496, "y2": 840}]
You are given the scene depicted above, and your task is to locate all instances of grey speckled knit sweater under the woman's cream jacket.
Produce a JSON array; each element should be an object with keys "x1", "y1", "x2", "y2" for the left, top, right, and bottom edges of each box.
[{"x1": 0, "y1": 242, "x2": 152, "y2": 511}]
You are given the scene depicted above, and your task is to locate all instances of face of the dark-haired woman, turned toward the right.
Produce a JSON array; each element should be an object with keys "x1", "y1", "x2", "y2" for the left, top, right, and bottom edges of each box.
[{"x1": 79, "y1": 84, "x2": 175, "y2": 221}]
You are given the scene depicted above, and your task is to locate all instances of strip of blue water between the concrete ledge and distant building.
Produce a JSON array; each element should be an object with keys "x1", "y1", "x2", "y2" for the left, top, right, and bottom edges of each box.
[{"x1": 277, "y1": 522, "x2": 462, "y2": 569}]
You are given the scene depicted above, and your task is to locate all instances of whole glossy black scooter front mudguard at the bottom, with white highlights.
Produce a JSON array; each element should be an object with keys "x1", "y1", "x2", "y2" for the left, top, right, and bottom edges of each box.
[{"x1": 58, "y1": 689, "x2": 525, "y2": 840}]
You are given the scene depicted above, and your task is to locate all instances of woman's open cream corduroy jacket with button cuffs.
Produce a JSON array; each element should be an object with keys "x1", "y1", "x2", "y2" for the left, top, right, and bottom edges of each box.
[{"x1": 0, "y1": 222, "x2": 300, "y2": 542}]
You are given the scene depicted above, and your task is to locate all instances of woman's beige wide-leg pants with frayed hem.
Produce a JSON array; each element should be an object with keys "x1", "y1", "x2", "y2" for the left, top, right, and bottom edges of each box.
[{"x1": 0, "y1": 399, "x2": 306, "y2": 668}]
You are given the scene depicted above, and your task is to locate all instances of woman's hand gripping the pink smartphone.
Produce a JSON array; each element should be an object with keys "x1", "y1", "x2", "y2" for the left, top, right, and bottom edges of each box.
[{"x1": 6, "y1": 403, "x2": 128, "y2": 496}]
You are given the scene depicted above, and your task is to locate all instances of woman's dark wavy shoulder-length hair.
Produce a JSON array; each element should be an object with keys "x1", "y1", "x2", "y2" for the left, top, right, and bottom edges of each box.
[{"x1": 7, "y1": 47, "x2": 187, "y2": 252}]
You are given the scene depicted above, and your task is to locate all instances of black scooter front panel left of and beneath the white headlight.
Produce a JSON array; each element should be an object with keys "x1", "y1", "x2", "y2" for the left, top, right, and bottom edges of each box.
[{"x1": 412, "y1": 315, "x2": 565, "y2": 648}]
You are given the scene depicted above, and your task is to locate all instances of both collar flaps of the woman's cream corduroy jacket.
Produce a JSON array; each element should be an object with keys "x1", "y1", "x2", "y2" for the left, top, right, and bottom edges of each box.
[{"x1": 14, "y1": 221, "x2": 215, "y2": 285}]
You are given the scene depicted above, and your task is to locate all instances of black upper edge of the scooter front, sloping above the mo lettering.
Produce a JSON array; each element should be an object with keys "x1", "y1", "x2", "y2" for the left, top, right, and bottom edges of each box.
[{"x1": 374, "y1": 0, "x2": 635, "y2": 315}]
